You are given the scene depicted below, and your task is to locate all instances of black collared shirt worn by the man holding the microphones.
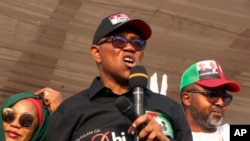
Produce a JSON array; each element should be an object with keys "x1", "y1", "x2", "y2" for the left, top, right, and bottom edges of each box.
[{"x1": 47, "y1": 77, "x2": 192, "y2": 141}]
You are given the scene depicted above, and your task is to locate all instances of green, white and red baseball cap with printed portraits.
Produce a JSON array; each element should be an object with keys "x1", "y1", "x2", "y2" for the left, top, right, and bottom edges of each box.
[{"x1": 180, "y1": 60, "x2": 240, "y2": 92}]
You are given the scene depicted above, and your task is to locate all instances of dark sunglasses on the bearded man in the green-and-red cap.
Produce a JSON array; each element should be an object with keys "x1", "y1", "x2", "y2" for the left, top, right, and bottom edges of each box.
[{"x1": 187, "y1": 90, "x2": 233, "y2": 106}]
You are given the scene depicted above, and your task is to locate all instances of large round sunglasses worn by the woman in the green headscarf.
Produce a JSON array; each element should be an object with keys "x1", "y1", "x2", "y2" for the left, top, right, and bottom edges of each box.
[{"x1": 2, "y1": 108, "x2": 34, "y2": 127}]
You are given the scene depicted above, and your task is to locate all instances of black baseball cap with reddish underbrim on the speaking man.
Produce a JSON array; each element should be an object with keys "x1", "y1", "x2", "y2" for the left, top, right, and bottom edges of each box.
[{"x1": 93, "y1": 13, "x2": 152, "y2": 44}]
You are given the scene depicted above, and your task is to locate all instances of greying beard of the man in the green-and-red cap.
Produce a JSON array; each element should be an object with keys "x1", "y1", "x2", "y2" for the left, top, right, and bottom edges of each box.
[{"x1": 191, "y1": 105, "x2": 224, "y2": 130}]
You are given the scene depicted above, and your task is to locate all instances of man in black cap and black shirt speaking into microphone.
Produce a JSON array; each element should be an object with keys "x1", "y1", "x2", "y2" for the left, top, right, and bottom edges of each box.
[{"x1": 47, "y1": 13, "x2": 192, "y2": 141}]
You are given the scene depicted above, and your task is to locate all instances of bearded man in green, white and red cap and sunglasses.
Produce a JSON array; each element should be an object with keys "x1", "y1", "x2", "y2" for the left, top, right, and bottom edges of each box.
[{"x1": 180, "y1": 60, "x2": 240, "y2": 141}]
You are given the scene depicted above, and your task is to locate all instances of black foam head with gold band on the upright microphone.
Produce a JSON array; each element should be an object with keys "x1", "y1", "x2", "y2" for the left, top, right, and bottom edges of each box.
[{"x1": 129, "y1": 65, "x2": 148, "y2": 88}]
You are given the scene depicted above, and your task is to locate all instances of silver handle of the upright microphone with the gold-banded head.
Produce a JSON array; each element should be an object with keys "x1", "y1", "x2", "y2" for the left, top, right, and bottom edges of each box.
[{"x1": 133, "y1": 87, "x2": 144, "y2": 141}]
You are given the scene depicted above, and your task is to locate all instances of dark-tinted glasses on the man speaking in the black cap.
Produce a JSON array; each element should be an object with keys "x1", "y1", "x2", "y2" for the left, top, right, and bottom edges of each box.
[{"x1": 97, "y1": 36, "x2": 147, "y2": 51}]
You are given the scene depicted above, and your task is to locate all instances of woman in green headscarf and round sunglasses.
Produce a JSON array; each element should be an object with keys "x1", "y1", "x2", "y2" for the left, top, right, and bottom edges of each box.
[{"x1": 0, "y1": 89, "x2": 62, "y2": 141}]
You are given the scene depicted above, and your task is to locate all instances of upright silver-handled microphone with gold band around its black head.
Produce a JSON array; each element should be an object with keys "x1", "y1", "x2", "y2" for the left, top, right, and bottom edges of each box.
[{"x1": 129, "y1": 65, "x2": 148, "y2": 115}]
